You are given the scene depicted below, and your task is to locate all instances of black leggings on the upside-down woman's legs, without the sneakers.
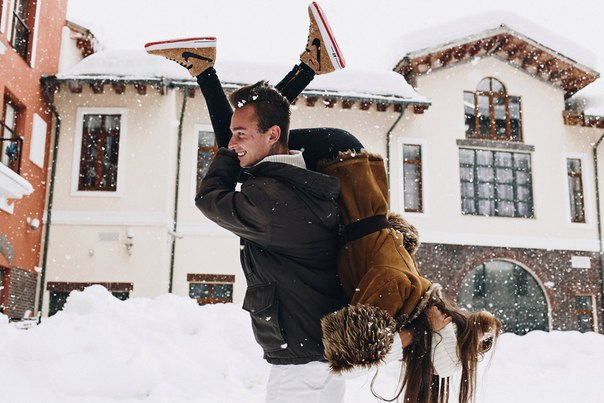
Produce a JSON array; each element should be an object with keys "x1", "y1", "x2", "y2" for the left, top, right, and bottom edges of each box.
[{"x1": 197, "y1": 63, "x2": 363, "y2": 170}]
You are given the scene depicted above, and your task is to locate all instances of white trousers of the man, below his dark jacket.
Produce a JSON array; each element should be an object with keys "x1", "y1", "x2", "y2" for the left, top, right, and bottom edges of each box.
[{"x1": 266, "y1": 362, "x2": 346, "y2": 403}]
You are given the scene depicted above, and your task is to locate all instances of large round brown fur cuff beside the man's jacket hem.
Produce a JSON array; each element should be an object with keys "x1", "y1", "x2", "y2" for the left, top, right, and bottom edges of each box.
[{"x1": 321, "y1": 304, "x2": 396, "y2": 374}]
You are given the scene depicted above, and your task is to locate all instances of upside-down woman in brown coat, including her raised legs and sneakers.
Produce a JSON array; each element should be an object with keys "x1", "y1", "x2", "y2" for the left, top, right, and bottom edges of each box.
[{"x1": 146, "y1": 3, "x2": 500, "y2": 402}]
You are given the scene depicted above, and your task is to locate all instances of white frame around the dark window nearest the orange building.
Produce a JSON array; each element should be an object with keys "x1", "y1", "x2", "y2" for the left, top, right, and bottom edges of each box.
[{"x1": 71, "y1": 107, "x2": 128, "y2": 197}]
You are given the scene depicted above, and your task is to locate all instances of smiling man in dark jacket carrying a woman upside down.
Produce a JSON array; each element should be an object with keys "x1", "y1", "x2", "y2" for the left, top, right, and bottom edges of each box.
[{"x1": 195, "y1": 81, "x2": 346, "y2": 403}]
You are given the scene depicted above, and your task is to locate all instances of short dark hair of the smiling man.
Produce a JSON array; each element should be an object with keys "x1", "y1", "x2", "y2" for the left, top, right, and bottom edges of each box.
[{"x1": 229, "y1": 80, "x2": 290, "y2": 147}]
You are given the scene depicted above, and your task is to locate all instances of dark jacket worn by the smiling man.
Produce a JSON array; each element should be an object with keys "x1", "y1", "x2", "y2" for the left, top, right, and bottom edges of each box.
[{"x1": 195, "y1": 149, "x2": 346, "y2": 364}]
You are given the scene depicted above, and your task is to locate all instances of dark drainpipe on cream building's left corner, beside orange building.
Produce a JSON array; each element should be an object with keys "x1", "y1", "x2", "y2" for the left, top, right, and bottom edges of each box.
[{"x1": 38, "y1": 76, "x2": 61, "y2": 316}]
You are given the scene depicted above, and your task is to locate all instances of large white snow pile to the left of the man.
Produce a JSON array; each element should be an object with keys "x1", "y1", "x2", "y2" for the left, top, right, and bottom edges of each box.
[{"x1": 0, "y1": 286, "x2": 268, "y2": 403}]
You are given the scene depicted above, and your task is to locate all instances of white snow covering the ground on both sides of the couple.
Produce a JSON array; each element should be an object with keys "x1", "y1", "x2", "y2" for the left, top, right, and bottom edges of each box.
[{"x1": 0, "y1": 286, "x2": 604, "y2": 403}]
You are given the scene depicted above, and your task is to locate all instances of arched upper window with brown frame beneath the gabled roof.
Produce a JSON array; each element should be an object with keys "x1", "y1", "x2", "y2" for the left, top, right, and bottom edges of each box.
[{"x1": 464, "y1": 77, "x2": 522, "y2": 141}]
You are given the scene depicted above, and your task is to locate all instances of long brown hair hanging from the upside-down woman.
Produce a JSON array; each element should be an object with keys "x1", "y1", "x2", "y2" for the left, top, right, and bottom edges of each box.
[{"x1": 382, "y1": 297, "x2": 501, "y2": 403}]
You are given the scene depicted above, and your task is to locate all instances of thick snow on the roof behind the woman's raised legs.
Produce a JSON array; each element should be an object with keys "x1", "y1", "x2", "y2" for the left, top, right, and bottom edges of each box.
[{"x1": 57, "y1": 49, "x2": 429, "y2": 104}]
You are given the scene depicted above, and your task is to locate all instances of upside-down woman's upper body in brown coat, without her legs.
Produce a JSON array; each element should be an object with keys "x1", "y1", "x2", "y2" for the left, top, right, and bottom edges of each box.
[{"x1": 319, "y1": 152, "x2": 501, "y2": 403}]
